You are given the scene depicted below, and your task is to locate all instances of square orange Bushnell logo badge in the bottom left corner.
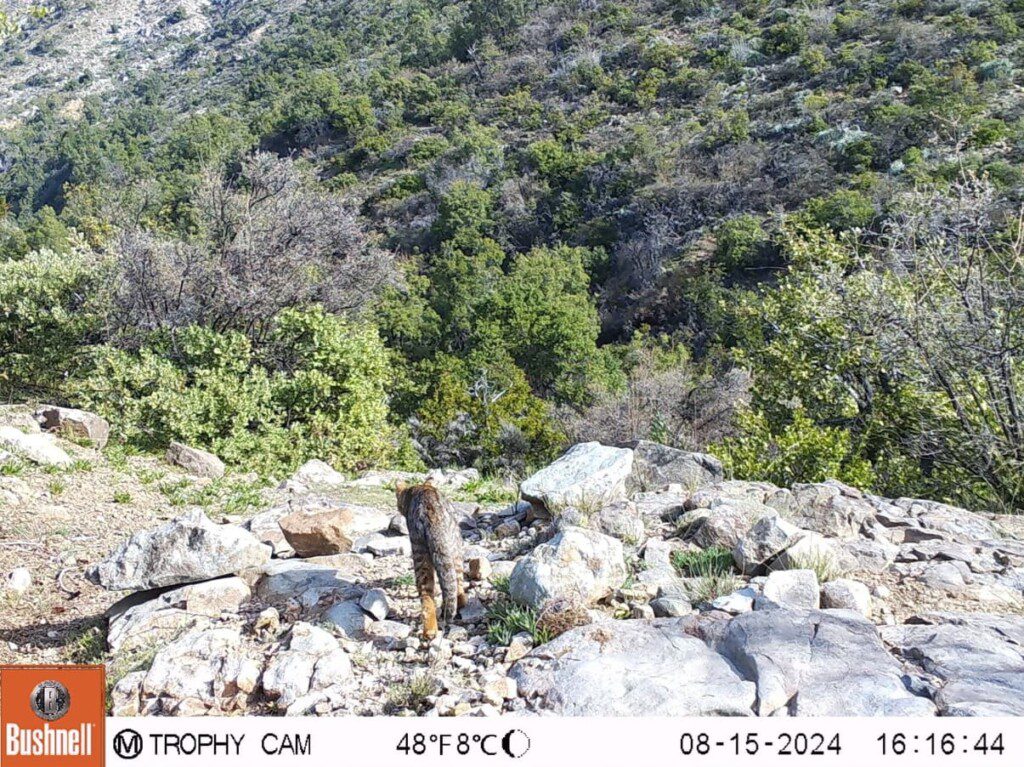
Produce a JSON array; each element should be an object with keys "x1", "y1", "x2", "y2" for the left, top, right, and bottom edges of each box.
[{"x1": 0, "y1": 666, "x2": 105, "y2": 767}]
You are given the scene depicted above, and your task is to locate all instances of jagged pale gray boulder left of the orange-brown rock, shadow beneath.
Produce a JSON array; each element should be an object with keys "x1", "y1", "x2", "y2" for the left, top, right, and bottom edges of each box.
[{"x1": 86, "y1": 509, "x2": 270, "y2": 591}]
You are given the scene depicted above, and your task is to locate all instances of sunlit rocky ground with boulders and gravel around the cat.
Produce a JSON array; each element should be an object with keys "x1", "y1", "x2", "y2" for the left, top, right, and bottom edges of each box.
[{"x1": 0, "y1": 408, "x2": 1024, "y2": 716}]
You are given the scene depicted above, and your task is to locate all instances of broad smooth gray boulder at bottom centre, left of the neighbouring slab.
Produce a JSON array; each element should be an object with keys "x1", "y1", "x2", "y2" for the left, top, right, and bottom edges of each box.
[{"x1": 509, "y1": 619, "x2": 755, "y2": 717}]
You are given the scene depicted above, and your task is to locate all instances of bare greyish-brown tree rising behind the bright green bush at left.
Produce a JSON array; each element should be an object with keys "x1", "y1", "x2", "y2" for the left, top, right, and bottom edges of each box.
[{"x1": 115, "y1": 154, "x2": 393, "y2": 341}]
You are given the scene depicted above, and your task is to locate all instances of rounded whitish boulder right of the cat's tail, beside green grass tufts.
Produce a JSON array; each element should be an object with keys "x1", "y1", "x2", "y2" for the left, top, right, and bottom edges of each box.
[{"x1": 509, "y1": 527, "x2": 626, "y2": 608}]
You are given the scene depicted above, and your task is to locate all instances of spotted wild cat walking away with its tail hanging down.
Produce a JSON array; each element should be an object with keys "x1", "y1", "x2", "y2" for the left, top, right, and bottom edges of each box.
[{"x1": 395, "y1": 482, "x2": 466, "y2": 639}]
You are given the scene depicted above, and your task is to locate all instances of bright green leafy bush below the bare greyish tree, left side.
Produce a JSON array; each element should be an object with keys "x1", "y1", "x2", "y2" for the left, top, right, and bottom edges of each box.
[{"x1": 75, "y1": 308, "x2": 399, "y2": 473}]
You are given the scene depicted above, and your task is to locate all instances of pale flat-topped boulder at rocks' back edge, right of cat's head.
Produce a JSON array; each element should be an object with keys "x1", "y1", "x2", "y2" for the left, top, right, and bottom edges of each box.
[{"x1": 519, "y1": 442, "x2": 633, "y2": 510}]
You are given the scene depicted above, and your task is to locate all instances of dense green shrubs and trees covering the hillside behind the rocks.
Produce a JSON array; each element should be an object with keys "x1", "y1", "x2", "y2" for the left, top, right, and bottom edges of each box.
[{"x1": 0, "y1": 0, "x2": 1024, "y2": 510}]
